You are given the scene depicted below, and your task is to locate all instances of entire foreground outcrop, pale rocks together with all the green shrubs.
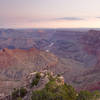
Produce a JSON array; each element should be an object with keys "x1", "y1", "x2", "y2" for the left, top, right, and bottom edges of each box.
[{"x1": 0, "y1": 70, "x2": 100, "y2": 100}]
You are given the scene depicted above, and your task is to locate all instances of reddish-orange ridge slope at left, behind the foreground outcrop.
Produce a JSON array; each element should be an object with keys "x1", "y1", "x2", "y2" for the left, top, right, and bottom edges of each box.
[{"x1": 0, "y1": 48, "x2": 58, "y2": 79}]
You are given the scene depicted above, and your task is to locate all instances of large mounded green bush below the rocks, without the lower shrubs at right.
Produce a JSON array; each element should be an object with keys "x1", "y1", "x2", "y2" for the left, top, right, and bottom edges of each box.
[{"x1": 31, "y1": 80, "x2": 76, "y2": 100}]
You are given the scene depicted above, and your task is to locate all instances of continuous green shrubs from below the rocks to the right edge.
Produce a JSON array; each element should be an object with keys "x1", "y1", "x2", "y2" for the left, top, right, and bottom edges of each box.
[{"x1": 31, "y1": 80, "x2": 100, "y2": 100}]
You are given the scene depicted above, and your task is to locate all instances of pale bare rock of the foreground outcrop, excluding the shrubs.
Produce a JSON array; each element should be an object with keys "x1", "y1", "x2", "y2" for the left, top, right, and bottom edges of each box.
[{"x1": 0, "y1": 70, "x2": 64, "y2": 100}]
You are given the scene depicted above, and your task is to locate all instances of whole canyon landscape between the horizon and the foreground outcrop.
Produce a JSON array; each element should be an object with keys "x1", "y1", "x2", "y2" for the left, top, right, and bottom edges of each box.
[{"x1": 0, "y1": 29, "x2": 100, "y2": 94}]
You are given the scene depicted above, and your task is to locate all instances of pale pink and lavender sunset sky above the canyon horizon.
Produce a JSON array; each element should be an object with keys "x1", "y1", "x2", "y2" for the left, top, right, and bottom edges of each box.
[{"x1": 0, "y1": 0, "x2": 100, "y2": 28}]
